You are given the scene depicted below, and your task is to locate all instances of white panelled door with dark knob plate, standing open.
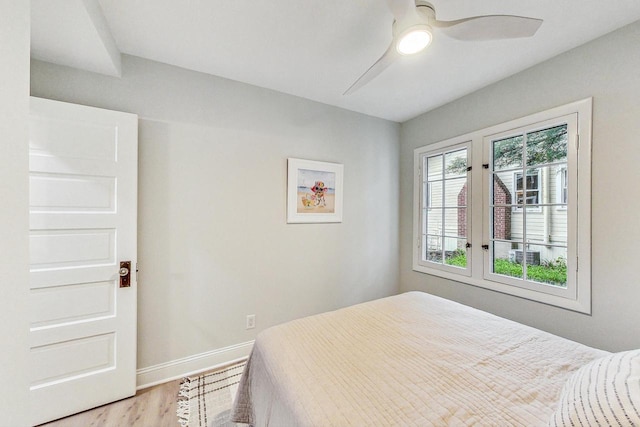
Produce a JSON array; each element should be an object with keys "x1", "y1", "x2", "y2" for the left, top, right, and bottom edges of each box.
[{"x1": 29, "y1": 98, "x2": 138, "y2": 425}]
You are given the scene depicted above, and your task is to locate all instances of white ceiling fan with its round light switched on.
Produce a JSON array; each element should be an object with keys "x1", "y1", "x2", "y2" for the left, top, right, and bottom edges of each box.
[{"x1": 343, "y1": 0, "x2": 542, "y2": 95}]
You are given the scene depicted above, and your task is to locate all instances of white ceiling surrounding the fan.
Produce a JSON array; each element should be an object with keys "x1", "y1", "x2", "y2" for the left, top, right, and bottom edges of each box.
[{"x1": 32, "y1": 0, "x2": 640, "y2": 122}]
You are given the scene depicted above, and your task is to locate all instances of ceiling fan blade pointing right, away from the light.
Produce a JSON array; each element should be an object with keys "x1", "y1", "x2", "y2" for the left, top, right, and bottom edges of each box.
[{"x1": 433, "y1": 15, "x2": 542, "y2": 41}]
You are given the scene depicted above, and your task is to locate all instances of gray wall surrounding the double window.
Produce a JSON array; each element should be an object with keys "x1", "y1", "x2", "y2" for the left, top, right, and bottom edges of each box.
[{"x1": 400, "y1": 22, "x2": 640, "y2": 351}]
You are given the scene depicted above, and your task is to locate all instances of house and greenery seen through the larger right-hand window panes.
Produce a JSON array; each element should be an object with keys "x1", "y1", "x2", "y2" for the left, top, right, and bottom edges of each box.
[{"x1": 487, "y1": 123, "x2": 568, "y2": 288}]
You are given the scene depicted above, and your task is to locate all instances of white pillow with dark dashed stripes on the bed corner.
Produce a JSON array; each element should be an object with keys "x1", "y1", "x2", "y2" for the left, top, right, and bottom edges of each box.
[{"x1": 549, "y1": 349, "x2": 640, "y2": 427}]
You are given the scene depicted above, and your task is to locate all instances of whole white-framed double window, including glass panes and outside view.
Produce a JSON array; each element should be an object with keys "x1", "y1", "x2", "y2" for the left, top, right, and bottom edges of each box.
[{"x1": 413, "y1": 99, "x2": 591, "y2": 313}]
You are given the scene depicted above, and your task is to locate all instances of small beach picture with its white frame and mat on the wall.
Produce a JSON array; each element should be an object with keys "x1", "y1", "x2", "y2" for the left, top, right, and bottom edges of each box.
[{"x1": 287, "y1": 158, "x2": 344, "y2": 223}]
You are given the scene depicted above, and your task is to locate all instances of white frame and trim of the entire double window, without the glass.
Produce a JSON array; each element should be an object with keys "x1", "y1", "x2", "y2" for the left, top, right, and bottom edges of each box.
[{"x1": 413, "y1": 98, "x2": 593, "y2": 314}]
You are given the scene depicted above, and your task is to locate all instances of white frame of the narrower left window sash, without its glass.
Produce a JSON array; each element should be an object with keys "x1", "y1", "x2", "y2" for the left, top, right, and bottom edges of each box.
[{"x1": 413, "y1": 138, "x2": 472, "y2": 277}]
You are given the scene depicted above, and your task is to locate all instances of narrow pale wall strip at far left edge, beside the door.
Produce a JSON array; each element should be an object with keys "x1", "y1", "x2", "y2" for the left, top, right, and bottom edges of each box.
[{"x1": 0, "y1": 1, "x2": 30, "y2": 426}]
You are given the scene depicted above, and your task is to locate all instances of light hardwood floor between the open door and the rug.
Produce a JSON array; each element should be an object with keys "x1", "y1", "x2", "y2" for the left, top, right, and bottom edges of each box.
[{"x1": 41, "y1": 380, "x2": 181, "y2": 427}]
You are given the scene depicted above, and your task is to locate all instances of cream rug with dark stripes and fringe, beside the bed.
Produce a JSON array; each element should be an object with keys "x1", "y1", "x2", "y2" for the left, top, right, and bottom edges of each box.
[{"x1": 178, "y1": 360, "x2": 247, "y2": 427}]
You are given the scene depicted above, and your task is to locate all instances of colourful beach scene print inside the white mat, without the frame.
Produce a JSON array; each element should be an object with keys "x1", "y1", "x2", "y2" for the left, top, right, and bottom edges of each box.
[{"x1": 297, "y1": 169, "x2": 336, "y2": 214}]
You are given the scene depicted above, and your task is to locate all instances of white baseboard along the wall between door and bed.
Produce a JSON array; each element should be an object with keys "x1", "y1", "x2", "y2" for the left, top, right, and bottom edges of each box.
[{"x1": 136, "y1": 341, "x2": 253, "y2": 390}]
